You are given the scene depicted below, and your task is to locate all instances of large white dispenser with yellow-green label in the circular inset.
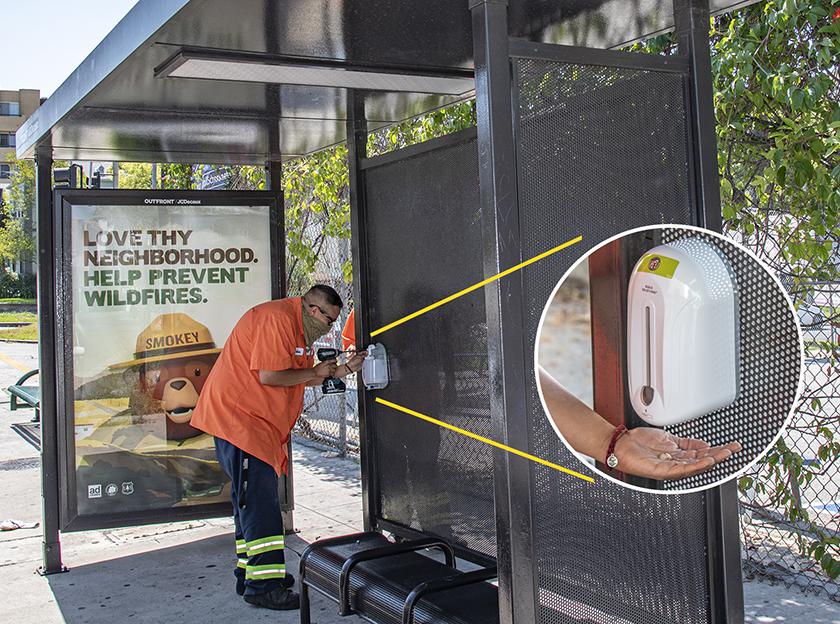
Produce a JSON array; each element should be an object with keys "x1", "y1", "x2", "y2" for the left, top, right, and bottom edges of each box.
[{"x1": 627, "y1": 238, "x2": 739, "y2": 427}]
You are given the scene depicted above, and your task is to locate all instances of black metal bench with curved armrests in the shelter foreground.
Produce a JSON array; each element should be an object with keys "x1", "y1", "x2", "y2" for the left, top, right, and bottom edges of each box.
[{"x1": 300, "y1": 532, "x2": 499, "y2": 624}]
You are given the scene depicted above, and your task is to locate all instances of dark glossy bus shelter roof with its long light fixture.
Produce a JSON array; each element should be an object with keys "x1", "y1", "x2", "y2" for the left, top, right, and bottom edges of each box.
[{"x1": 17, "y1": 0, "x2": 750, "y2": 164}]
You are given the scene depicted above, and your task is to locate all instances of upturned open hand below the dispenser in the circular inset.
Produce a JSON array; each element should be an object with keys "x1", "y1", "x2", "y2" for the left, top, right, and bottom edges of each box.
[{"x1": 615, "y1": 427, "x2": 741, "y2": 479}]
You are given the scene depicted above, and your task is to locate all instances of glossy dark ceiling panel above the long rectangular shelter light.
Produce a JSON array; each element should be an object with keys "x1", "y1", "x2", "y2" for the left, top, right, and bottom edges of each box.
[{"x1": 155, "y1": 0, "x2": 472, "y2": 67}]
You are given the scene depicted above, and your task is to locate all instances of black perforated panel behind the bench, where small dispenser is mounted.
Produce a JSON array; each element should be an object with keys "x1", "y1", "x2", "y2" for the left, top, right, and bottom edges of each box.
[{"x1": 365, "y1": 132, "x2": 496, "y2": 556}]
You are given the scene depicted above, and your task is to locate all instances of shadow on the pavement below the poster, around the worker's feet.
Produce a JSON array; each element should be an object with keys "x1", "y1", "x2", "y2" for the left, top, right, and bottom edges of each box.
[{"x1": 48, "y1": 535, "x2": 348, "y2": 624}]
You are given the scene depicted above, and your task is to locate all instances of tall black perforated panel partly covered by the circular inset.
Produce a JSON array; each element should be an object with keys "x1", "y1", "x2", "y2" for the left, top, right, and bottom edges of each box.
[{"x1": 514, "y1": 59, "x2": 710, "y2": 624}]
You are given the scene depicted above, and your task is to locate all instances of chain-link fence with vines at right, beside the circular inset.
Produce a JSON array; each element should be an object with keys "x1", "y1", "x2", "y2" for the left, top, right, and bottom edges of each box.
[{"x1": 730, "y1": 224, "x2": 840, "y2": 602}]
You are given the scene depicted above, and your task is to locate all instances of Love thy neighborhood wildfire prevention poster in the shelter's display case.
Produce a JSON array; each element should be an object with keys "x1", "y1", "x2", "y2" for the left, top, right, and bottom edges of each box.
[{"x1": 70, "y1": 200, "x2": 271, "y2": 515}]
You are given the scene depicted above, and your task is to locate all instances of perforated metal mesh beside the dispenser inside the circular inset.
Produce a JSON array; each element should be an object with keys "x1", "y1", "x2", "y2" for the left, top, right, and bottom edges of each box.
[{"x1": 662, "y1": 229, "x2": 801, "y2": 489}]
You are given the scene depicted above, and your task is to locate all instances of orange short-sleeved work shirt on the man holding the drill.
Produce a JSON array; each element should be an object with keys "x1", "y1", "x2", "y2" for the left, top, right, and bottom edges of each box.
[{"x1": 190, "y1": 297, "x2": 314, "y2": 475}]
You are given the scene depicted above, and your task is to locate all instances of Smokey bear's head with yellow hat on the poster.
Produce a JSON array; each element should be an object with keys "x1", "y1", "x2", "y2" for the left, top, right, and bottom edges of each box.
[{"x1": 110, "y1": 313, "x2": 221, "y2": 440}]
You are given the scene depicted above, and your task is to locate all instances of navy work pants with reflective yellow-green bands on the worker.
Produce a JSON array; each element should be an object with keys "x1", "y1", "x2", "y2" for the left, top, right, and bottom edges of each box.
[{"x1": 215, "y1": 438, "x2": 286, "y2": 595}]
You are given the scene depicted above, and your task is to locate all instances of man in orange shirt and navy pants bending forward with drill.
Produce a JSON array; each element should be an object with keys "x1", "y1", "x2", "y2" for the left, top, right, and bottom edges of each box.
[{"x1": 192, "y1": 284, "x2": 366, "y2": 610}]
